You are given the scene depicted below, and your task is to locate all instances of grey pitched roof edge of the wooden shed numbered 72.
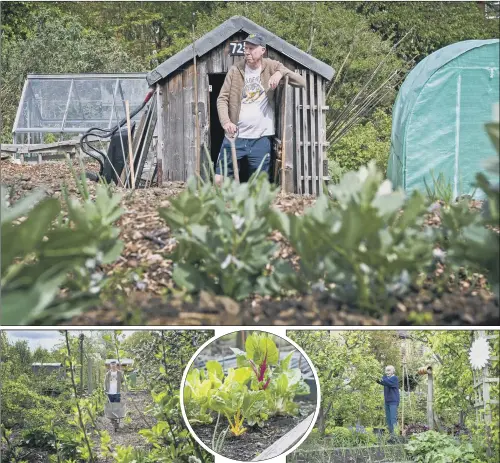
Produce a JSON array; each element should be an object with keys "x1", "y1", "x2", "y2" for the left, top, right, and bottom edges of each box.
[{"x1": 147, "y1": 16, "x2": 335, "y2": 85}]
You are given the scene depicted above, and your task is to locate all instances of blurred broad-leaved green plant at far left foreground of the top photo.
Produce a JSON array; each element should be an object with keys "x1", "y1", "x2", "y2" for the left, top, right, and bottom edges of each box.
[{"x1": 0, "y1": 169, "x2": 123, "y2": 325}]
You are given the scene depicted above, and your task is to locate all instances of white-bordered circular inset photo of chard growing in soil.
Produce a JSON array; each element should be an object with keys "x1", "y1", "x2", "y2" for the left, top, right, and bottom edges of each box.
[{"x1": 181, "y1": 330, "x2": 320, "y2": 462}]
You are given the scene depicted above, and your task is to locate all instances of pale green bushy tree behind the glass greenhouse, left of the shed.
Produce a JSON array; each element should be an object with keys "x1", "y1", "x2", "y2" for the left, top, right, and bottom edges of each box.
[{"x1": 0, "y1": 7, "x2": 146, "y2": 143}]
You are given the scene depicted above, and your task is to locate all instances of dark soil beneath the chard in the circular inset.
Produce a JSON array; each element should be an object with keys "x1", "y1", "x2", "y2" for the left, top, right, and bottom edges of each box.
[{"x1": 193, "y1": 402, "x2": 316, "y2": 461}]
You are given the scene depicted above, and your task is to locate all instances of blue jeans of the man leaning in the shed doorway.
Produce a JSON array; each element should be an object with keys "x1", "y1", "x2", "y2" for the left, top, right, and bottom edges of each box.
[{"x1": 215, "y1": 137, "x2": 271, "y2": 177}]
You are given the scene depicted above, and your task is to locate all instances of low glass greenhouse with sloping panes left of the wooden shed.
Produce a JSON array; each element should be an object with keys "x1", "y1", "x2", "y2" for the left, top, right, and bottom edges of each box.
[{"x1": 12, "y1": 73, "x2": 148, "y2": 144}]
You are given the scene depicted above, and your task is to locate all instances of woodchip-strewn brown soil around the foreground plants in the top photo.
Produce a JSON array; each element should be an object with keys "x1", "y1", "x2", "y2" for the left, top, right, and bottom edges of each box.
[{"x1": 0, "y1": 160, "x2": 500, "y2": 326}]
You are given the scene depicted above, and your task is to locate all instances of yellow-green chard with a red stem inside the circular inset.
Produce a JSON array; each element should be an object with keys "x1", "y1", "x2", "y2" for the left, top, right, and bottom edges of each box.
[{"x1": 184, "y1": 333, "x2": 309, "y2": 436}]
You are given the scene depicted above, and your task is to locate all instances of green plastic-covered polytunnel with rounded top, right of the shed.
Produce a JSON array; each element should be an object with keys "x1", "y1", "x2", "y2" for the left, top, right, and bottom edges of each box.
[{"x1": 387, "y1": 39, "x2": 500, "y2": 199}]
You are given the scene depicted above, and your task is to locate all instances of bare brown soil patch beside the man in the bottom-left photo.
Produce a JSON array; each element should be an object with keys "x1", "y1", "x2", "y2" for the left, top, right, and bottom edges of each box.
[{"x1": 93, "y1": 391, "x2": 156, "y2": 463}]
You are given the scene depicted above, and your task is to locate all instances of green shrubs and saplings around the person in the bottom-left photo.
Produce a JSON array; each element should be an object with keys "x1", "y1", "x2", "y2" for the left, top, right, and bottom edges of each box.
[{"x1": 0, "y1": 331, "x2": 213, "y2": 463}]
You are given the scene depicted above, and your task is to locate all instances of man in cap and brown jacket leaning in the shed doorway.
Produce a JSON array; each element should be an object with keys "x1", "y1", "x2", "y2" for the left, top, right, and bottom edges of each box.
[{"x1": 215, "y1": 34, "x2": 306, "y2": 183}]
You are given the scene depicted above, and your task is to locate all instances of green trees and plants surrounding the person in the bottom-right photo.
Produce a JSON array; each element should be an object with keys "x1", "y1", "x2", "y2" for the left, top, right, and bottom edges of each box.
[{"x1": 288, "y1": 330, "x2": 499, "y2": 463}]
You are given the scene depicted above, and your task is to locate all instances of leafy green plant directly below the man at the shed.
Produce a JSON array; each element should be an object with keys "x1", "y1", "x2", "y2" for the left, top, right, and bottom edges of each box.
[{"x1": 160, "y1": 170, "x2": 284, "y2": 300}]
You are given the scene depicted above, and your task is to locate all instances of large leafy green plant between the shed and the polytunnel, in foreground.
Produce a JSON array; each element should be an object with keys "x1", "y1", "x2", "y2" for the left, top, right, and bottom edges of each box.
[{"x1": 275, "y1": 162, "x2": 432, "y2": 311}]
